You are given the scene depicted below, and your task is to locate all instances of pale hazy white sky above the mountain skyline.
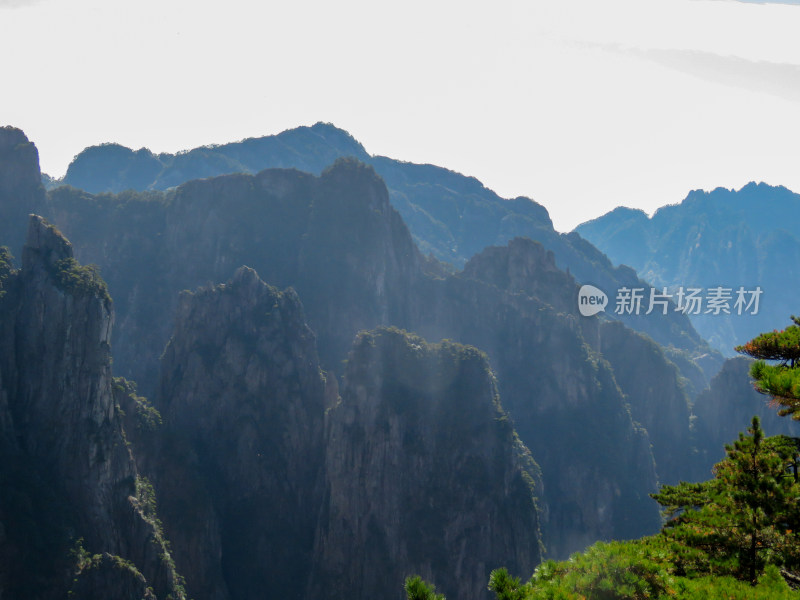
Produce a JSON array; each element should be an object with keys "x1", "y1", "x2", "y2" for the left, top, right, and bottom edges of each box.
[{"x1": 0, "y1": 0, "x2": 800, "y2": 231}]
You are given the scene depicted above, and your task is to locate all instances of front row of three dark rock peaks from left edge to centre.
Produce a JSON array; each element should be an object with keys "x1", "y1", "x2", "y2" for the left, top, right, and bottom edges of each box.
[{"x1": 0, "y1": 216, "x2": 552, "y2": 599}]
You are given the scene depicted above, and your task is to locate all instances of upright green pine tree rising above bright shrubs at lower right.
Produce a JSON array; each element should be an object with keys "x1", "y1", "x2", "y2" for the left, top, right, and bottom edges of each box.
[{"x1": 652, "y1": 417, "x2": 800, "y2": 584}]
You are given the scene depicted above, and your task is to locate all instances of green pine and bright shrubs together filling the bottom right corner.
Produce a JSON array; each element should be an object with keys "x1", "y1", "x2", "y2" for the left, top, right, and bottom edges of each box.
[{"x1": 406, "y1": 417, "x2": 800, "y2": 600}]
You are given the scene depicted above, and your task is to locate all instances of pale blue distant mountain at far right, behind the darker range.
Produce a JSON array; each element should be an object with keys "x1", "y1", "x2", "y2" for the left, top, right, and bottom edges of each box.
[{"x1": 575, "y1": 183, "x2": 800, "y2": 355}]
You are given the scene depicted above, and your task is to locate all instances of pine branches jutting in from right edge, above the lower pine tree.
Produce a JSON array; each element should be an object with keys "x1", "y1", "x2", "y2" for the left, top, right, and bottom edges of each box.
[{"x1": 736, "y1": 315, "x2": 800, "y2": 420}]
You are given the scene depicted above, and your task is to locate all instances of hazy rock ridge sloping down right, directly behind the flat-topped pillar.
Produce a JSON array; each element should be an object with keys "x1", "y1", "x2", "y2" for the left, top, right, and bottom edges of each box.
[{"x1": 415, "y1": 276, "x2": 659, "y2": 557}]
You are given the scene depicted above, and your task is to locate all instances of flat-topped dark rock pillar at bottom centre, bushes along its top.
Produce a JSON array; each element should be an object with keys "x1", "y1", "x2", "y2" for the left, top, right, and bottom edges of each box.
[{"x1": 310, "y1": 329, "x2": 541, "y2": 599}]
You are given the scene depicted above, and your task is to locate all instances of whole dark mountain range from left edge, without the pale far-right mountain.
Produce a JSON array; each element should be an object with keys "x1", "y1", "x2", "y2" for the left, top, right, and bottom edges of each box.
[{"x1": 0, "y1": 124, "x2": 788, "y2": 599}]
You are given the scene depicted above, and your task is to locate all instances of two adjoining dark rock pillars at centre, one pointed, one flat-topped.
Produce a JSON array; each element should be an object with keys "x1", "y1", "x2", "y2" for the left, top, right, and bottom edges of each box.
[{"x1": 144, "y1": 267, "x2": 542, "y2": 599}]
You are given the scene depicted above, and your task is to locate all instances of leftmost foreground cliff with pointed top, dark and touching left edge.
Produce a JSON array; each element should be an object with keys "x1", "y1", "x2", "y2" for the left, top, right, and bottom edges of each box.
[{"x1": 0, "y1": 216, "x2": 182, "y2": 598}]
